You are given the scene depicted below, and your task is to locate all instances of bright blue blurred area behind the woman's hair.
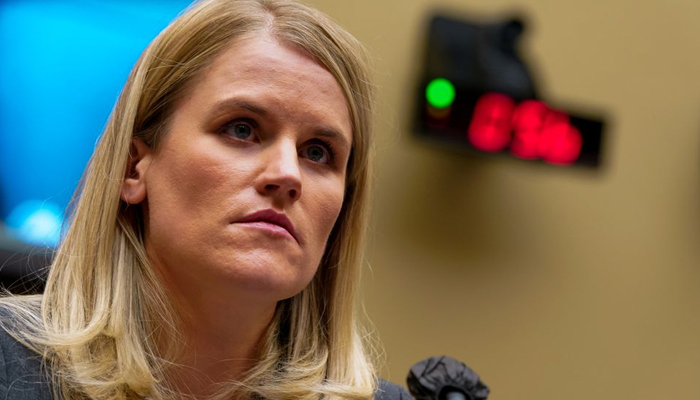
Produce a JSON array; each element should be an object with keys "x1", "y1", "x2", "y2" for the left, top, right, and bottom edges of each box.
[{"x1": 0, "y1": 0, "x2": 189, "y2": 246}]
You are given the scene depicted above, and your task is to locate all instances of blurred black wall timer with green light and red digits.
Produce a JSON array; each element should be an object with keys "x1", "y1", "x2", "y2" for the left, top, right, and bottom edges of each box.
[{"x1": 415, "y1": 16, "x2": 604, "y2": 167}]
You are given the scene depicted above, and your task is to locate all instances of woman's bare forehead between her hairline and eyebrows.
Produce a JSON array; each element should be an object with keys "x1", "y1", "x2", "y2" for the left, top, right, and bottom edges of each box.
[{"x1": 178, "y1": 35, "x2": 352, "y2": 142}]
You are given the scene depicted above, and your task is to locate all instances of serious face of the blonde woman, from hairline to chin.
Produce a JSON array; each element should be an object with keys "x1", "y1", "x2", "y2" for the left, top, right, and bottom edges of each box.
[{"x1": 128, "y1": 35, "x2": 352, "y2": 301}]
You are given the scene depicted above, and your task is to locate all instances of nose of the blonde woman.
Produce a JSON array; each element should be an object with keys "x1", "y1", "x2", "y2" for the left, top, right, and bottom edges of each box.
[{"x1": 255, "y1": 143, "x2": 301, "y2": 202}]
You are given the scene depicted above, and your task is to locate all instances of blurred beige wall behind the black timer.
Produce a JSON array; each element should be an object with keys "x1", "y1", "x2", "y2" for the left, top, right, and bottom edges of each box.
[{"x1": 310, "y1": 0, "x2": 700, "y2": 400}]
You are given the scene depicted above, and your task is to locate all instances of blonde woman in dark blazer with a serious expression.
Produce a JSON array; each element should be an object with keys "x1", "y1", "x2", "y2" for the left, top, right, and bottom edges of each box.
[{"x1": 0, "y1": 0, "x2": 408, "y2": 399}]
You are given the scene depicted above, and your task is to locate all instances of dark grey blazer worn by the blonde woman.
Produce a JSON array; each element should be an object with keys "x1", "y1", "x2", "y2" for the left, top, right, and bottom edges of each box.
[{"x1": 0, "y1": 328, "x2": 412, "y2": 400}]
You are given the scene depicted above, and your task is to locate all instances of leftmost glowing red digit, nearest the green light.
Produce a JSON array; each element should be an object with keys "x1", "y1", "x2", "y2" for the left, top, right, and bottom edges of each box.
[{"x1": 467, "y1": 93, "x2": 515, "y2": 152}]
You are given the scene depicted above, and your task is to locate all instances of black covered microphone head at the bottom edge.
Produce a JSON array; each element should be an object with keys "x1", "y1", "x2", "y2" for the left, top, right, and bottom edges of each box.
[{"x1": 406, "y1": 356, "x2": 490, "y2": 400}]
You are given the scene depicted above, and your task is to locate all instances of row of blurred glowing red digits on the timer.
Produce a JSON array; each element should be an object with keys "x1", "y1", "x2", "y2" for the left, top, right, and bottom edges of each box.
[{"x1": 467, "y1": 93, "x2": 583, "y2": 165}]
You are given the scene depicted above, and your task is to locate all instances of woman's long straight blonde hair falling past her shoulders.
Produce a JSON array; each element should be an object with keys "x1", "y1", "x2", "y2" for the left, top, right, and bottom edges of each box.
[{"x1": 2, "y1": 0, "x2": 376, "y2": 400}]
